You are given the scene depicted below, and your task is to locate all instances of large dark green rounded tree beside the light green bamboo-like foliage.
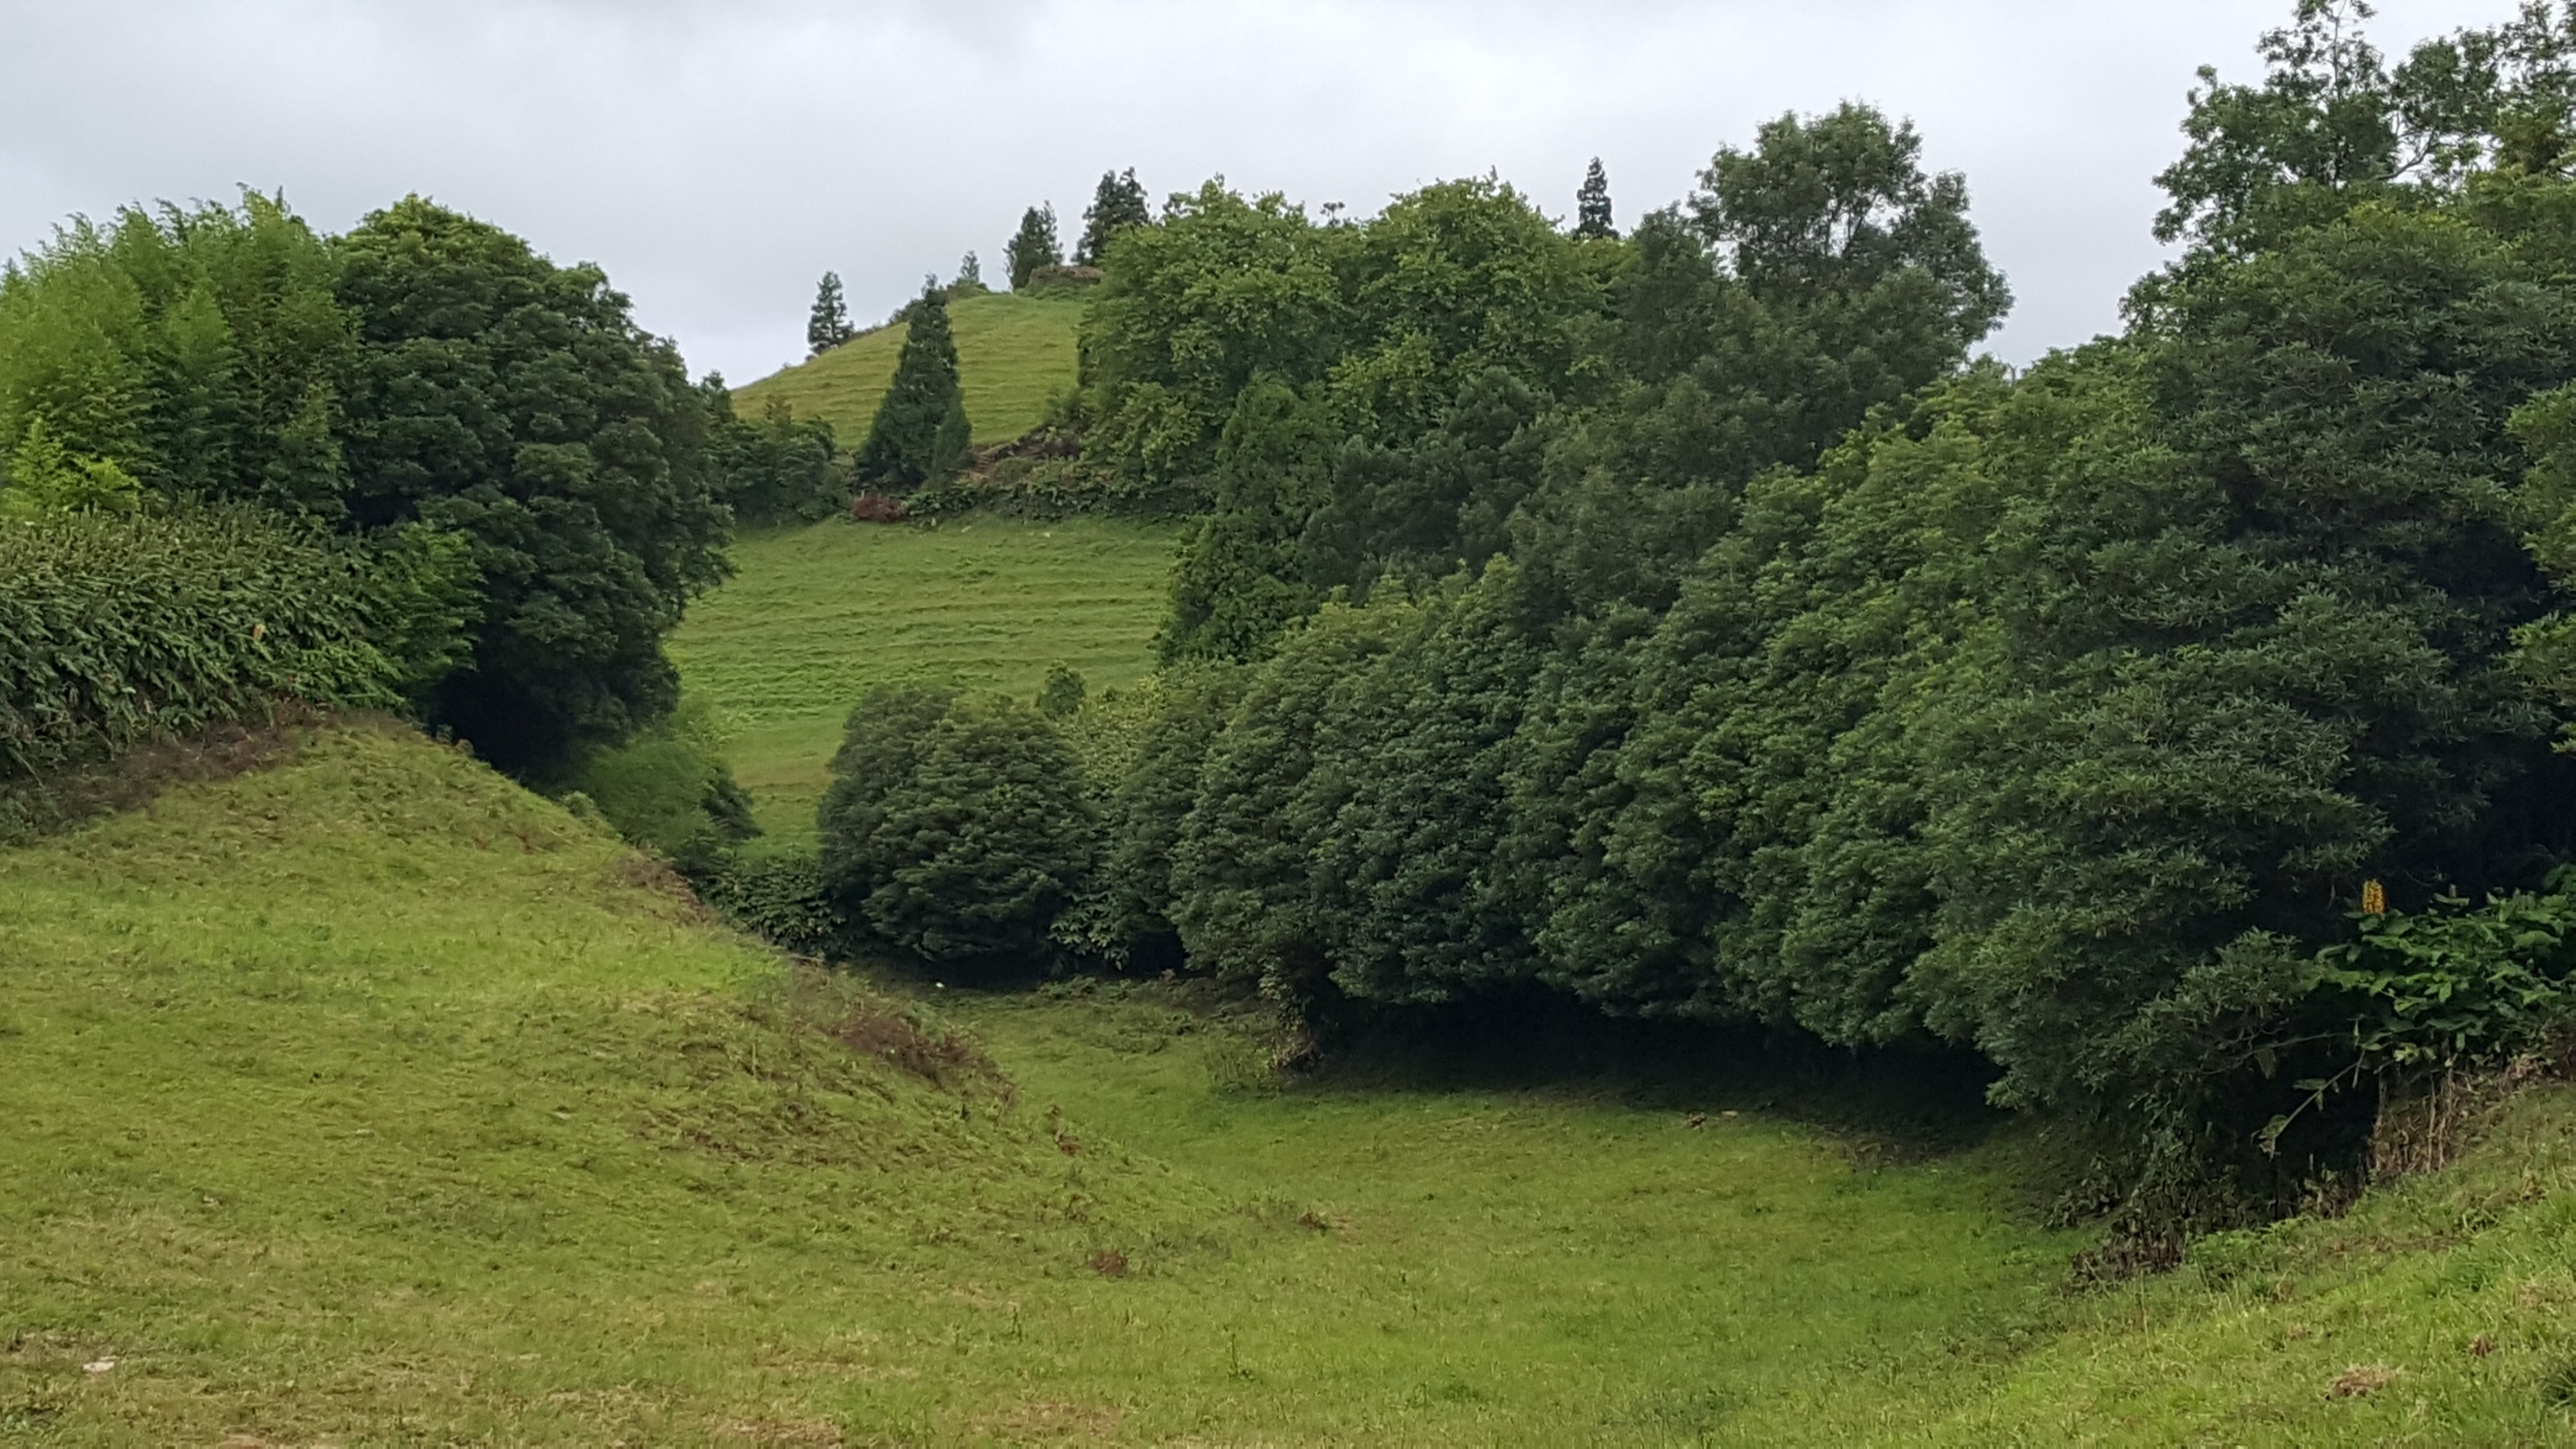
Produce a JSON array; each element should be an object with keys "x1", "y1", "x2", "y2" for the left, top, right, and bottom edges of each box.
[{"x1": 335, "y1": 196, "x2": 729, "y2": 771}]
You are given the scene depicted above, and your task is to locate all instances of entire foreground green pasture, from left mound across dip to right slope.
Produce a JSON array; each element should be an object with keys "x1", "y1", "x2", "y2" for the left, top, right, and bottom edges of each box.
[{"x1": 15, "y1": 727, "x2": 2576, "y2": 1446}]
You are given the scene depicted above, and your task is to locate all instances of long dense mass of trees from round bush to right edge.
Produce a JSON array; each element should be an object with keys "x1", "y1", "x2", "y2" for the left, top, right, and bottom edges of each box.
[{"x1": 824, "y1": 0, "x2": 2576, "y2": 1196}]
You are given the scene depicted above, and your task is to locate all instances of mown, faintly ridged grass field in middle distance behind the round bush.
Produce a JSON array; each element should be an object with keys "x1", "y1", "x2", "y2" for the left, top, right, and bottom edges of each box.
[{"x1": 670, "y1": 518, "x2": 1177, "y2": 841}]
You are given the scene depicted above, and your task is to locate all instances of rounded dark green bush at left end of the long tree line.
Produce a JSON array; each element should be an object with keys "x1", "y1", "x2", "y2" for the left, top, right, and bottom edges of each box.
[{"x1": 820, "y1": 689, "x2": 1097, "y2": 964}]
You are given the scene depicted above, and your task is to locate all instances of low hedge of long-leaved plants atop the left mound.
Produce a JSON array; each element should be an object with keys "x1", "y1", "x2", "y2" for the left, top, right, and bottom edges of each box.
[{"x1": 0, "y1": 510, "x2": 471, "y2": 781}]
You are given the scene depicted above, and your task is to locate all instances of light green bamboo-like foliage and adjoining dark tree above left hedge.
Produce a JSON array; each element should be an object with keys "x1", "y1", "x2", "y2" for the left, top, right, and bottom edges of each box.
[{"x1": 0, "y1": 193, "x2": 726, "y2": 771}]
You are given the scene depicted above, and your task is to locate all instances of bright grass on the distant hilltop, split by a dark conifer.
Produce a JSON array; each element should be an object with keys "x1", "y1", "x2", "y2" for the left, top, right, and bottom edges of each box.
[{"x1": 734, "y1": 291, "x2": 1082, "y2": 449}]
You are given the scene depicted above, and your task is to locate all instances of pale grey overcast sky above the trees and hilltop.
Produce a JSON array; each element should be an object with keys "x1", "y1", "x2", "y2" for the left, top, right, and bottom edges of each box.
[{"x1": 0, "y1": 0, "x2": 2509, "y2": 381}]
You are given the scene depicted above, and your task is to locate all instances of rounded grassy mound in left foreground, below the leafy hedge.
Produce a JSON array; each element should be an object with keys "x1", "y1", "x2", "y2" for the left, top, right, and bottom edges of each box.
[{"x1": 0, "y1": 727, "x2": 1218, "y2": 1444}]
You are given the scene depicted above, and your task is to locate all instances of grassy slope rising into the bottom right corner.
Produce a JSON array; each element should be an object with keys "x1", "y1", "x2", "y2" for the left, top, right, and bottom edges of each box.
[{"x1": 1914, "y1": 1085, "x2": 2576, "y2": 1446}]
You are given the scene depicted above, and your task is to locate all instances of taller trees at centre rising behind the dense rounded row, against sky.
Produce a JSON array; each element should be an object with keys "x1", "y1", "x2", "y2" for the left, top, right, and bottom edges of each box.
[{"x1": 1084, "y1": 106, "x2": 2007, "y2": 658}]
